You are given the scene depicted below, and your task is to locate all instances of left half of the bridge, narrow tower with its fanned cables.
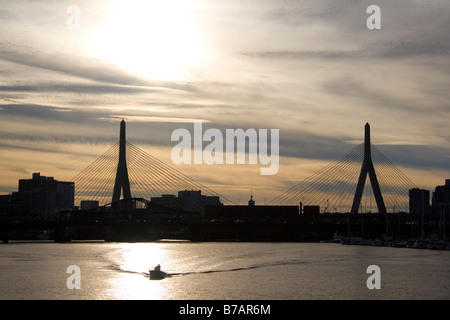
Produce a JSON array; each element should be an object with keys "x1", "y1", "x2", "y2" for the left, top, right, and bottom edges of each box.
[{"x1": 72, "y1": 120, "x2": 233, "y2": 205}]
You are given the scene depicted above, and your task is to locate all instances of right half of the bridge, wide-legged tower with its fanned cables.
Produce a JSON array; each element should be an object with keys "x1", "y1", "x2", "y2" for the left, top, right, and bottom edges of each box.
[{"x1": 270, "y1": 124, "x2": 415, "y2": 213}]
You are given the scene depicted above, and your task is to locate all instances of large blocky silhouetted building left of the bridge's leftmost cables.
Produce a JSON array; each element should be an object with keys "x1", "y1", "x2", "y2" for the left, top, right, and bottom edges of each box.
[{"x1": 11, "y1": 172, "x2": 75, "y2": 219}]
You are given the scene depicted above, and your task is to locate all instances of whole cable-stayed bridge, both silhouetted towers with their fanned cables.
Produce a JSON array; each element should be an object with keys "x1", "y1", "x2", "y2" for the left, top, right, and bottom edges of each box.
[{"x1": 72, "y1": 120, "x2": 415, "y2": 213}]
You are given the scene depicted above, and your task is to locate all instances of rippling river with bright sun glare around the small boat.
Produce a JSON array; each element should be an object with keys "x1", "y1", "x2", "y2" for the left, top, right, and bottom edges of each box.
[{"x1": 0, "y1": 241, "x2": 450, "y2": 300}]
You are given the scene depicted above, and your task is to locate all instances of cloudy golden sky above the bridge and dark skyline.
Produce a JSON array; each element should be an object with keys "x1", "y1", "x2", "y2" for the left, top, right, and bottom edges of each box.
[{"x1": 0, "y1": 0, "x2": 450, "y2": 204}]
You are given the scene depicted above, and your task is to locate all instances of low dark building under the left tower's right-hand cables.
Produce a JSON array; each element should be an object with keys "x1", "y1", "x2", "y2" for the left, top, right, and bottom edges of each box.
[{"x1": 150, "y1": 190, "x2": 222, "y2": 216}]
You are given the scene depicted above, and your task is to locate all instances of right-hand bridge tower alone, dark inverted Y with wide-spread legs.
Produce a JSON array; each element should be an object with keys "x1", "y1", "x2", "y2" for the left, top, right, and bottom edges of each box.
[{"x1": 351, "y1": 123, "x2": 386, "y2": 213}]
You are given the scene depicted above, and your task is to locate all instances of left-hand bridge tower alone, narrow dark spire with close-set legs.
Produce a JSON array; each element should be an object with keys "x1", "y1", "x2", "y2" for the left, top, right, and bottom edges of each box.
[{"x1": 112, "y1": 120, "x2": 131, "y2": 203}]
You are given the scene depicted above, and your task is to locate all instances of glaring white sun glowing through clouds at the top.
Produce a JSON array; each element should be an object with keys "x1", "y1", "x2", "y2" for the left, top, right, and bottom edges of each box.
[{"x1": 92, "y1": 0, "x2": 202, "y2": 80}]
